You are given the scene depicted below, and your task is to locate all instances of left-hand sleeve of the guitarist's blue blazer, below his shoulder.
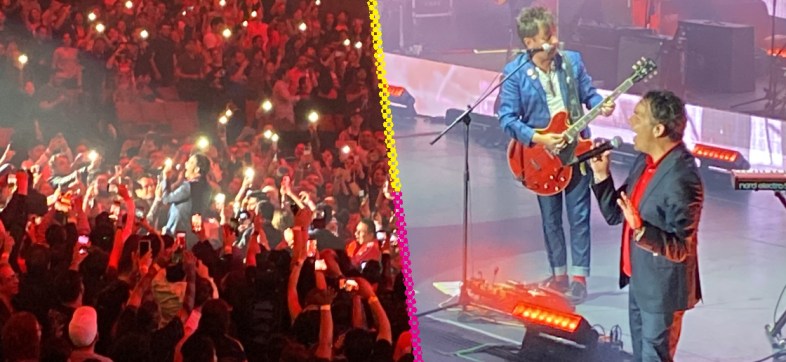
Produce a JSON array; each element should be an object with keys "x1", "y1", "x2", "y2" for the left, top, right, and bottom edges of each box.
[{"x1": 498, "y1": 63, "x2": 535, "y2": 145}]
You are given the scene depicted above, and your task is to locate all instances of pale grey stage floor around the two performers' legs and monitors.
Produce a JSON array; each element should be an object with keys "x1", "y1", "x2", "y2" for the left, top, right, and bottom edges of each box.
[{"x1": 395, "y1": 119, "x2": 786, "y2": 362}]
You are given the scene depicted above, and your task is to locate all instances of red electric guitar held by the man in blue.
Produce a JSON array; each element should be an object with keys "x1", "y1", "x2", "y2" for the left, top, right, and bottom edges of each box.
[{"x1": 508, "y1": 58, "x2": 657, "y2": 196}]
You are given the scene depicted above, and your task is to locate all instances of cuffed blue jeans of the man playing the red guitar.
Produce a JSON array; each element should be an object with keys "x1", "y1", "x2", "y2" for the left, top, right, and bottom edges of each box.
[{"x1": 538, "y1": 165, "x2": 592, "y2": 276}]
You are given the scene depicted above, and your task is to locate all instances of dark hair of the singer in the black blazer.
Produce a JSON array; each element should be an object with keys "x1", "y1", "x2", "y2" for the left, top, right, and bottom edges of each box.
[{"x1": 642, "y1": 90, "x2": 688, "y2": 142}]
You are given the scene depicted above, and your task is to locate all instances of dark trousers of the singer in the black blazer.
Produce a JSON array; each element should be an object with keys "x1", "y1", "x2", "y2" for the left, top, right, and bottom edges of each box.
[{"x1": 628, "y1": 293, "x2": 685, "y2": 362}]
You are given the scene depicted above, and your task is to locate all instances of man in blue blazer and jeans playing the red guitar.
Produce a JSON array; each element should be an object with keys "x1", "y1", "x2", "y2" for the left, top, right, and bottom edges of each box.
[{"x1": 497, "y1": 7, "x2": 614, "y2": 304}]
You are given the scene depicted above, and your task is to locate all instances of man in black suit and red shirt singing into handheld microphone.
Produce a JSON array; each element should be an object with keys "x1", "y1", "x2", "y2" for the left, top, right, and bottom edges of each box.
[{"x1": 590, "y1": 91, "x2": 704, "y2": 361}]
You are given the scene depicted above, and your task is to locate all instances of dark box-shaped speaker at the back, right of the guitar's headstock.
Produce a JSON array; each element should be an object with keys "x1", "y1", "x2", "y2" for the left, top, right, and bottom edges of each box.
[{"x1": 677, "y1": 20, "x2": 756, "y2": 93}]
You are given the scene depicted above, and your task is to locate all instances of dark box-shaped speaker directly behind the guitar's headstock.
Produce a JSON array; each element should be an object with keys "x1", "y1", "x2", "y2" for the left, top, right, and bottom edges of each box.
[{"x1": 617, "y1": 35, "x2": 671, "y2": 94}]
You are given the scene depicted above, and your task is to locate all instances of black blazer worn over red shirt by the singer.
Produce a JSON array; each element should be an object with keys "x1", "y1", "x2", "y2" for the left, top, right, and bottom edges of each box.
[{"x1": 592, "y1": 144, "x2": 704, "y2": 313}]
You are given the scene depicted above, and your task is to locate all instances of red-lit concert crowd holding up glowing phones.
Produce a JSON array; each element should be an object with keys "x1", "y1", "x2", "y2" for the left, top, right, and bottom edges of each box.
[{"x1": 0, "y1": 0, "x2": 413, "y2": 361}]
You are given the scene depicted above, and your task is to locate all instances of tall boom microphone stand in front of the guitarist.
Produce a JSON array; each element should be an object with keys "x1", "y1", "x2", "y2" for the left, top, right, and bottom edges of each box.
[{"x1": 415, "y1": 50, "x2": 537, "y2": 317}]
